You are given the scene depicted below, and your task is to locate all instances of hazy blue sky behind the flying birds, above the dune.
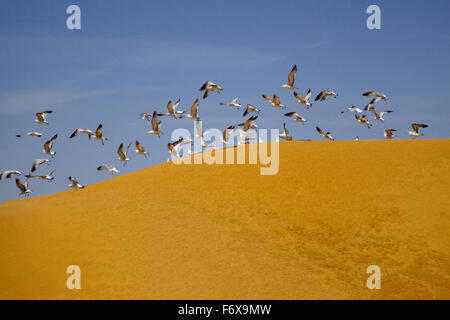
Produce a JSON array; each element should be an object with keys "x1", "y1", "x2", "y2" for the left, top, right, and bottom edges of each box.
[{"x1": 0, "y1": 0, "x2": 450, "y2": 201}]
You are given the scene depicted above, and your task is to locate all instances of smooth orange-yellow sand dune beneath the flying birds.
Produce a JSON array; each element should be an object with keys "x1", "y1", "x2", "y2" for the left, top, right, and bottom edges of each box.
[{"x1": 0, "y1": 140, "x2": 450, "y2": 299}]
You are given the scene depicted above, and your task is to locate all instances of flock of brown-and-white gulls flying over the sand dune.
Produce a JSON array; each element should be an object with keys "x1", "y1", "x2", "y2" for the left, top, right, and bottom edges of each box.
[{"x1": 0, "y1": 65, "x2": 428, "y2": 196}]
